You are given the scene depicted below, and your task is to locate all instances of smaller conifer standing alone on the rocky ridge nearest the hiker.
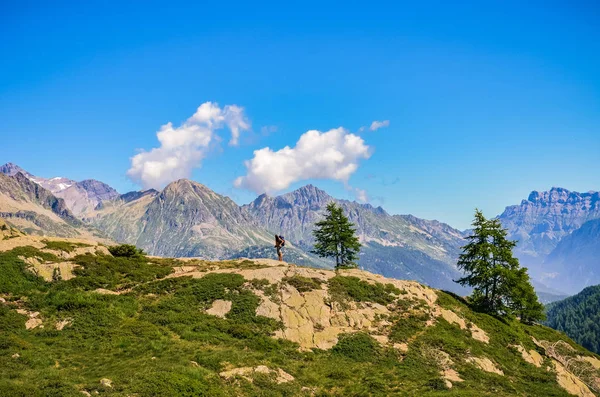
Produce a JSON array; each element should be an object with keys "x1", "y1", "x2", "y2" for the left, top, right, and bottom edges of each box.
[{"x1": 312, "y1": 202, "x2": 361, "y2": 269}]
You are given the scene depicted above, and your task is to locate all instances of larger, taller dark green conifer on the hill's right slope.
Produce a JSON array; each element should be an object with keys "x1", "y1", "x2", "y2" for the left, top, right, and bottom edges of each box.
[{"x1": 457, "y1": 210, "x2": 544, "y2": 322}]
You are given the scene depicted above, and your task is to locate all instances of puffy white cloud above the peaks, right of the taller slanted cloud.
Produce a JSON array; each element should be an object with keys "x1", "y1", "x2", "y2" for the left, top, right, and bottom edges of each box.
[{"x1": 234, "y1": 127, "x2": 371, "y2": 193}]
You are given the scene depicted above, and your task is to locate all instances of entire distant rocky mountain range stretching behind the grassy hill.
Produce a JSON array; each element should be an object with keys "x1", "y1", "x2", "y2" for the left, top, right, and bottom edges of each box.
[{"x1": 0, "y1": 163, "x2": 600, "y2": 296}]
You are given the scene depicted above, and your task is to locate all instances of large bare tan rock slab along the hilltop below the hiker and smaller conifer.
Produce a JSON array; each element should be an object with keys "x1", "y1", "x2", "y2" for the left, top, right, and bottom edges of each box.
[{"x1": 168, "y1": 260, "x2": 478, "y2": 349}]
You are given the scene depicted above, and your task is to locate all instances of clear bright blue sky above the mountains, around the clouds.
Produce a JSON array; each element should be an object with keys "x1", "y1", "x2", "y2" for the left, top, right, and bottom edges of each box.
[{"x1": 0, "y1": 1, "x2": 600, "y2": 228}]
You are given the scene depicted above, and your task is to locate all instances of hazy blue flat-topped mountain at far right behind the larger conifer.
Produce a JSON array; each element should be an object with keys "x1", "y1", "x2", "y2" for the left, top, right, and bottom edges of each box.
[{"x1": 498, "y1": 188, "x2": 600, "y2": 293}]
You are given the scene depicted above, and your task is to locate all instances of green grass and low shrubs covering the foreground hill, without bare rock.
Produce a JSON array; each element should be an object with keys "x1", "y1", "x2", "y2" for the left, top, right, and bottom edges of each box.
[{"x1": 0, "y1": 243, "x2": 589, "y2": 397}]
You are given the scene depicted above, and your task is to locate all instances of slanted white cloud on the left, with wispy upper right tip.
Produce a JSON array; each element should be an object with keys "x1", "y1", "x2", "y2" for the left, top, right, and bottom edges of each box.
[{"x1": 127, "y1": 102, "x2": 250, "y2": 189}]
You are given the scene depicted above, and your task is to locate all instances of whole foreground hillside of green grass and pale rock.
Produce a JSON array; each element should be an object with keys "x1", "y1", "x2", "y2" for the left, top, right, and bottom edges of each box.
[{"x1": 0, "y1": 244, "x2": 600, "y2": 396}]
